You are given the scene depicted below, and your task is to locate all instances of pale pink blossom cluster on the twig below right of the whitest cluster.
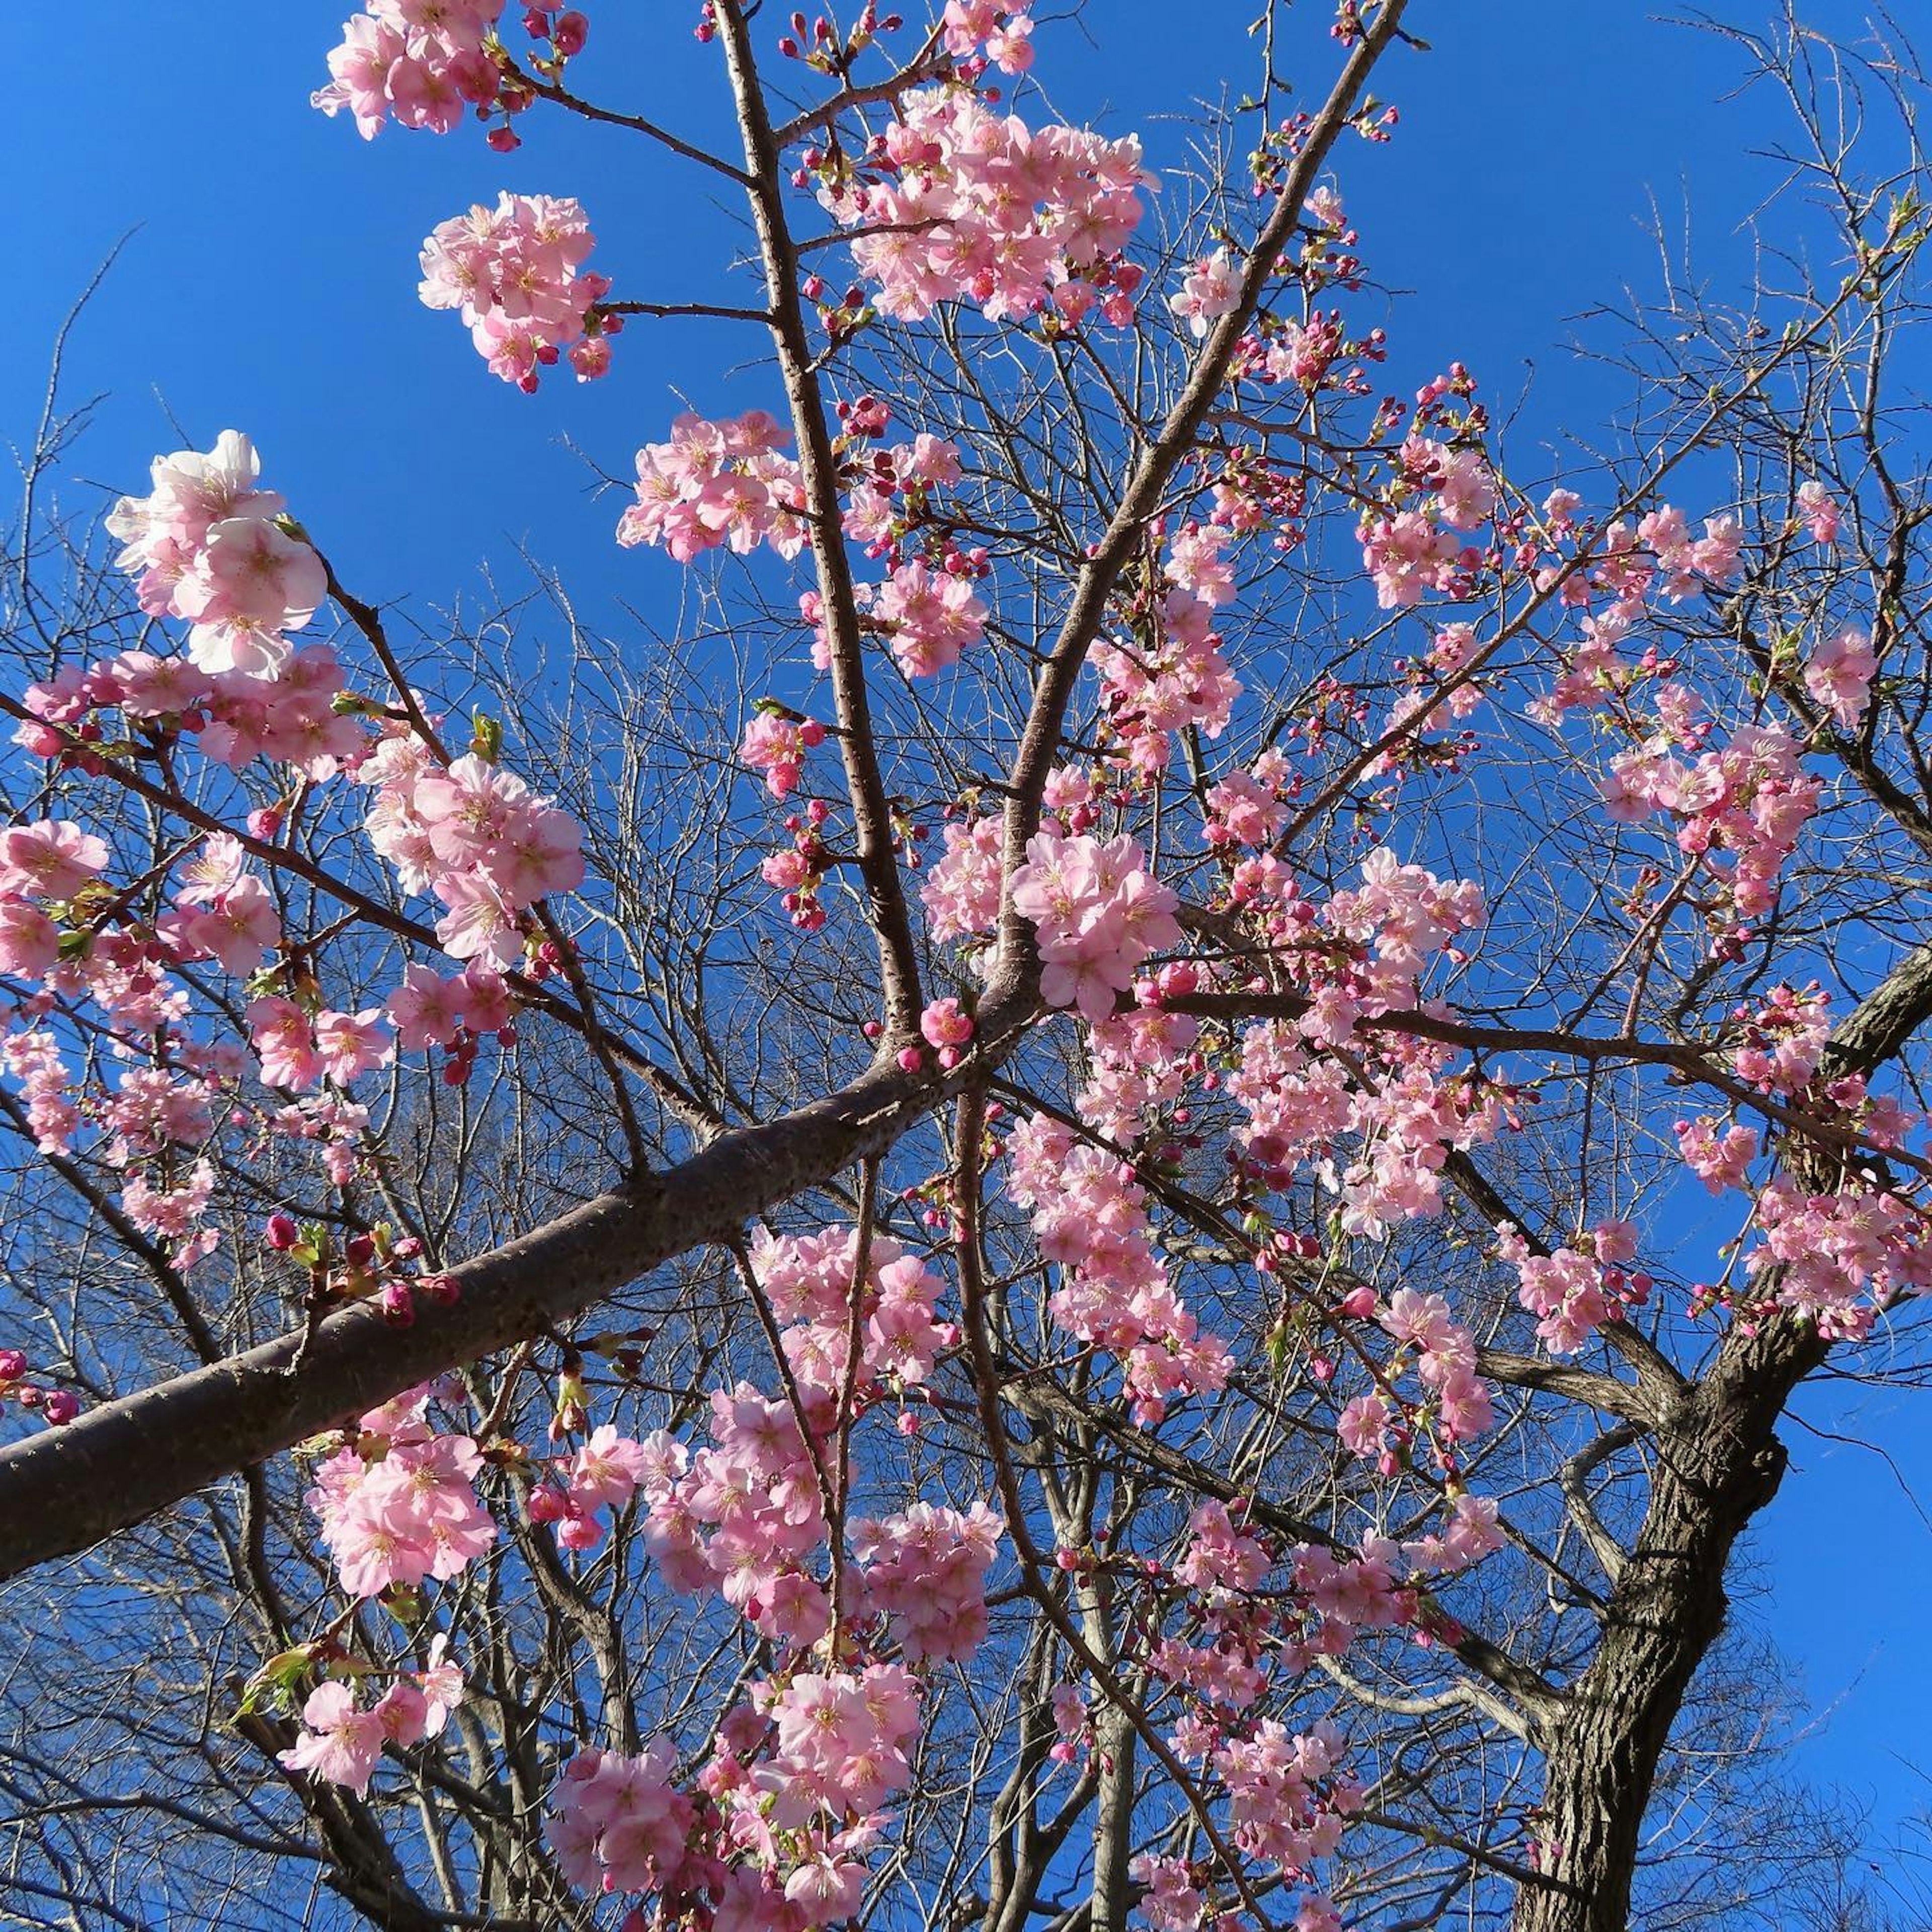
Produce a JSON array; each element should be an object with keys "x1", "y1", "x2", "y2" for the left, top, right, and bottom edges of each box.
[{"x1": 356, "y1": 729, "x2": 584, "y2": 966}]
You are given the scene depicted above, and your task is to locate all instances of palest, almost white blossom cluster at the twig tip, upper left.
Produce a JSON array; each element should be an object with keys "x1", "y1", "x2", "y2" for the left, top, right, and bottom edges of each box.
[{"x1": 106, "y1": 429, "x2": 329, "y2": 678}]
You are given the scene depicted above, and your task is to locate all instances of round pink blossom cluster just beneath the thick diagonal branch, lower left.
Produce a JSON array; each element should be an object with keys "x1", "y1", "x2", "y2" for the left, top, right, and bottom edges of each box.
[{"x1": 303, "y1": 1389, "x2": 497, "y2": 1596}]
